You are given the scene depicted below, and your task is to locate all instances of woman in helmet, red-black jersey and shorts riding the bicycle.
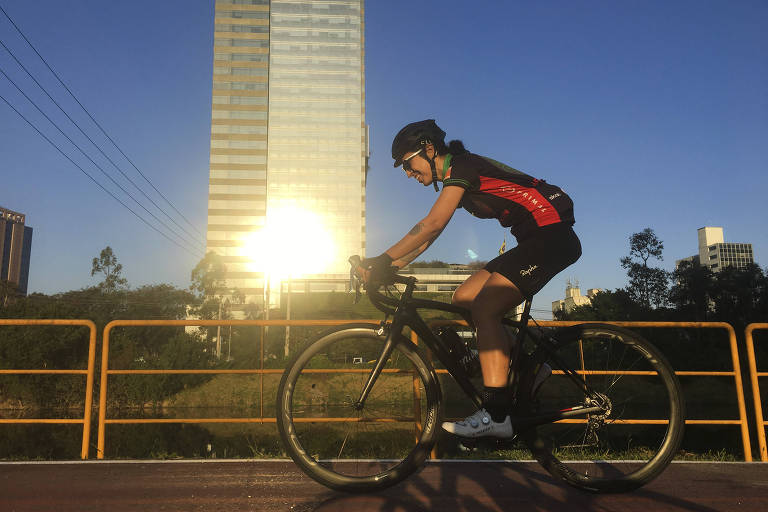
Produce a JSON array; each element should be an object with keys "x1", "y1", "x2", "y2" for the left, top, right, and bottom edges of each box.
[{"x1": 360, "y1": 119, "x2": 581, "y2": 438}]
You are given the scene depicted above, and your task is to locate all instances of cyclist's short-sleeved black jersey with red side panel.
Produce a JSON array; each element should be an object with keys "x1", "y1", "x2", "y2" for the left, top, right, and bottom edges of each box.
[{"x1": 443, "y1": 153, "x2": 574, "y2": 241}]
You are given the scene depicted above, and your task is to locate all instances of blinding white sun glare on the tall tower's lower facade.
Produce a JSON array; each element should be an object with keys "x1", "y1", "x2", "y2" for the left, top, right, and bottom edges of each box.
[{"x1": 242, "y1": 207, "x2": 336, "y2": 281}]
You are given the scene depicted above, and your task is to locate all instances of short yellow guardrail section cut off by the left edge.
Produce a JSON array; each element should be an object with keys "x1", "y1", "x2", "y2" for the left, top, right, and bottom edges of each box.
[{"x1": 0, "y1": 319, "x2": 96, "y2": 459}]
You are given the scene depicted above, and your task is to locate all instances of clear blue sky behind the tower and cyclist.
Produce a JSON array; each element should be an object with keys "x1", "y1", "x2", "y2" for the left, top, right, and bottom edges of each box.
[{"x1": 0, "y1": 0, "x2": 768, "y2": 316}]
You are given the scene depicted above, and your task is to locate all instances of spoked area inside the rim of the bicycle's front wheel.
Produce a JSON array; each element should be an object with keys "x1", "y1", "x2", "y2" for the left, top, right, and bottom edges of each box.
[{"x1": 280, "y1": 331, "x2": 435, "y2": 485}]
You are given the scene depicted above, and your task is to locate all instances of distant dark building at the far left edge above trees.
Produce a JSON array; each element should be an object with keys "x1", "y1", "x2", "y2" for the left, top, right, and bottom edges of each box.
[{"x1": 0, "y1": 206, "x2": 32, "y2": 295}]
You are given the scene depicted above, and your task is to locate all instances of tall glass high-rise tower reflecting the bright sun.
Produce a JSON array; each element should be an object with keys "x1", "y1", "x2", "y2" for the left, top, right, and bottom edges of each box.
[{"x1": 207, "y1": 0, "x2": 368, "y2": 303}]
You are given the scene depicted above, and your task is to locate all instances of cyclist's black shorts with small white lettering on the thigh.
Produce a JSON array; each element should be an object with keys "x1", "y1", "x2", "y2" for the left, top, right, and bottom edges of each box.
[{"x1": 485, "y1": 225, "x2": 581, "y2": 298}]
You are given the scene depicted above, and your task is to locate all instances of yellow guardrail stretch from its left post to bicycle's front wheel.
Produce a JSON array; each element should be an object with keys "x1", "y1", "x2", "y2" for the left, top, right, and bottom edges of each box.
[{"x1": 96, "y1": 319, "x2": 380, "y2": 459}]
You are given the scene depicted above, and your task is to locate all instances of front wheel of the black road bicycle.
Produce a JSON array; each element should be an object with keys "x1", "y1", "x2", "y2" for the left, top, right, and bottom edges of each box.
[{"x1": 277, "y1": 324, "x2": 440, "y2": 492}]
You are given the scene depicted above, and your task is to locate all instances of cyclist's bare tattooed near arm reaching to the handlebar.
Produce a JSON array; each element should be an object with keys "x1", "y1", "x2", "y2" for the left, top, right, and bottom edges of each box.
[{"x1": 387, "y1": 186, "x2": 464, "y2": 268}]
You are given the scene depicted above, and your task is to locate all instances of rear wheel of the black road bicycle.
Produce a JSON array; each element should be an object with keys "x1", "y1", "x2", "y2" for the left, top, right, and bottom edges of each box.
[{"x1": 527, "y1": 324, "x2": 685, "y2": 492}]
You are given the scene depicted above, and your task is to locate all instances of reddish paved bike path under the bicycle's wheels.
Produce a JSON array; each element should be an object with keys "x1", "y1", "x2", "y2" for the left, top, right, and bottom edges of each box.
[{"x1": 0, "y1": 460, "x2": 768, "y2": 512}]
